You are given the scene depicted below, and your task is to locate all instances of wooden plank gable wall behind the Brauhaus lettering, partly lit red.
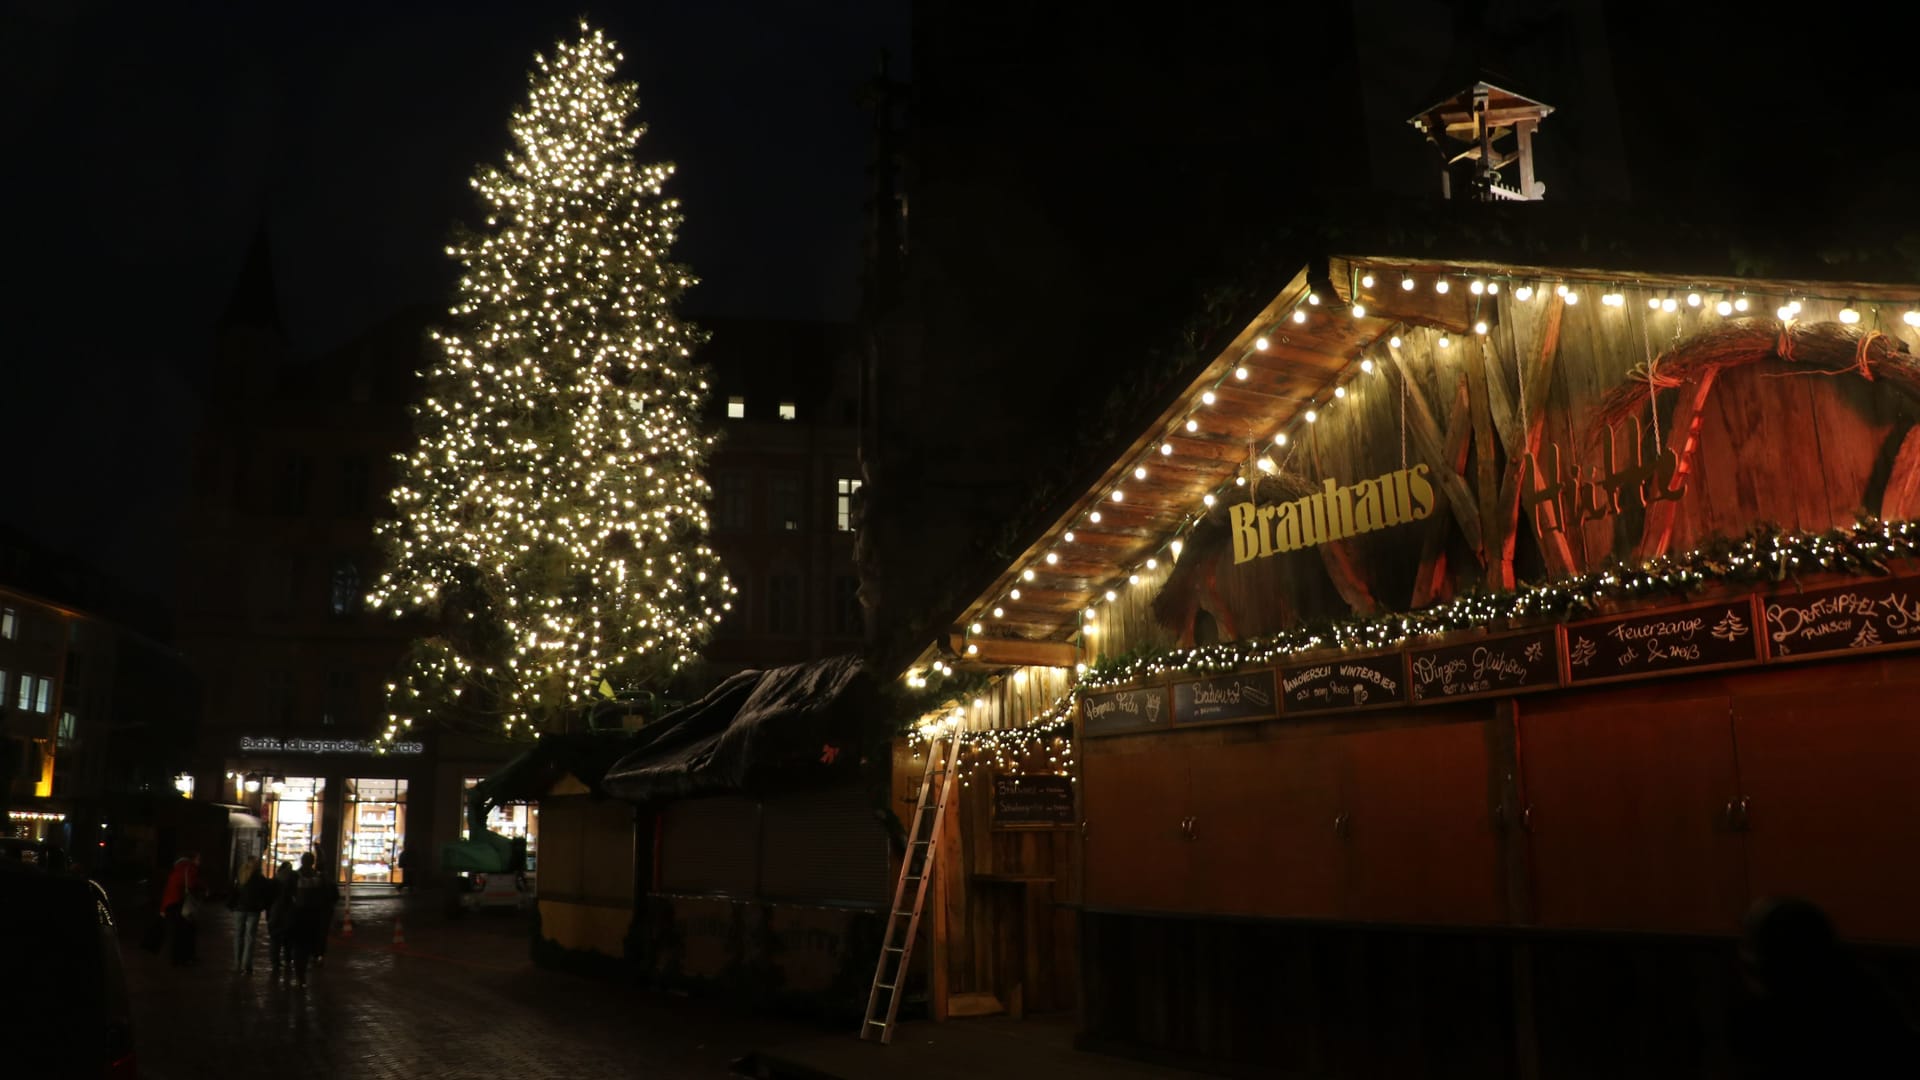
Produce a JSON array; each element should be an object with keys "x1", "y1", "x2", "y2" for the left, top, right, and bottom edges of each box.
[{"x1": 1091, "y1": 284, "x2": 1920, "y2": 657}]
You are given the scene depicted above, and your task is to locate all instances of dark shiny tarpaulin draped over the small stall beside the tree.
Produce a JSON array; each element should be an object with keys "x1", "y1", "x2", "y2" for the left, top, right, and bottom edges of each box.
[{"x1": 601, "y1": 655, "x2": 874, "y2": 803}]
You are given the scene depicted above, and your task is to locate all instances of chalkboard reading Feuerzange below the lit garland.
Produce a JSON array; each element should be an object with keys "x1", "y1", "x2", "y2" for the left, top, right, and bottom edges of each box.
[{"x1": 1567, "y1": 596, "x2": 1761, "y2": 684}]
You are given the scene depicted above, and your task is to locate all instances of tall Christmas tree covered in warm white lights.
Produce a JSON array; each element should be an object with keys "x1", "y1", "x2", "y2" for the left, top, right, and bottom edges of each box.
[{"x1": 369, "y1": 25, "x2": 735, "y2": 742}]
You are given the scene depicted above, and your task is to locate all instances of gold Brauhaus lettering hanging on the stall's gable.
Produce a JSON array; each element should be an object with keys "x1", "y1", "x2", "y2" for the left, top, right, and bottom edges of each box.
[{"x1": 1227, "y1": 465, "x2": 1434, "y2": 563}]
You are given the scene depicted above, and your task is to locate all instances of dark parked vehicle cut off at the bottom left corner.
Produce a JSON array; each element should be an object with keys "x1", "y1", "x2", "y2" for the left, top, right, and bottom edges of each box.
[{"x1": 0, "y1": 859, "x2": 138, "y2": 1080}]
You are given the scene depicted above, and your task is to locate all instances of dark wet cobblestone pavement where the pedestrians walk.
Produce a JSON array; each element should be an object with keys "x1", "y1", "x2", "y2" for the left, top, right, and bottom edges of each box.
[{"x1": 121, "y1": 897, "x2": 822, "y2": 1080}]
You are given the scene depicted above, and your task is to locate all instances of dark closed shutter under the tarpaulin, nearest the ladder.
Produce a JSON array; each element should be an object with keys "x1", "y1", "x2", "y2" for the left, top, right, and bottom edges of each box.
[{"x1": 760, "y1": 786, "x2": 887, "y2": 907}]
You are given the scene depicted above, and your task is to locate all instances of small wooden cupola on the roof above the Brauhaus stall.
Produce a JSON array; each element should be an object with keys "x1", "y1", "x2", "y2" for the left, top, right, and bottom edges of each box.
[{"x1": 1407, "y1": 81, "x2": 1553, "y2": 202}]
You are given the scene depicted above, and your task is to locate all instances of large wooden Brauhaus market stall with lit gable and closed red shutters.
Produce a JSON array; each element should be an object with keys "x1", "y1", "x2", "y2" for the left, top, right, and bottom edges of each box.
[{"x1": 890, "y1": 254, "x2": 1920, "y2": 1076}]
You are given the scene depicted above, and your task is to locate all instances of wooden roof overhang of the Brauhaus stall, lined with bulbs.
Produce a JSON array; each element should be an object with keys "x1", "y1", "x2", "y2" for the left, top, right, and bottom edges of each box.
[{"x1": 918, "y1": 256, "x2": 1920, "y2": 669}]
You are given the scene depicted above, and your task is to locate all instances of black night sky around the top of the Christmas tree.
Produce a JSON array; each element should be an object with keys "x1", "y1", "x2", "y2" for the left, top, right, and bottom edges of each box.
[{"x1": 0, "y1": 0, "x2": 908, "y2": 594}]
